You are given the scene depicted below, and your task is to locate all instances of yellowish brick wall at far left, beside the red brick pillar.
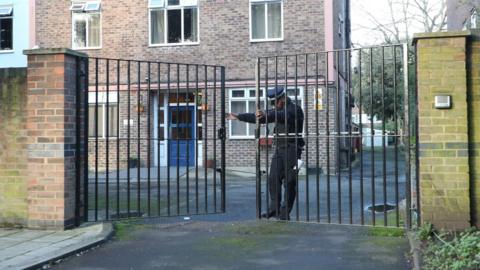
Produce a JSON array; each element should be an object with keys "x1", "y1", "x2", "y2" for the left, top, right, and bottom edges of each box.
[{"x1": 0, "y1": 69, "x2": 27, "y2": 227}]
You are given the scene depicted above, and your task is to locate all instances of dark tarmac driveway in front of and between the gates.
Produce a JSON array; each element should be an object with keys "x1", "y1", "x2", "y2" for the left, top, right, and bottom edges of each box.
[{"x1": 53, "y1": 179, "x2": 409, "y2": 270}]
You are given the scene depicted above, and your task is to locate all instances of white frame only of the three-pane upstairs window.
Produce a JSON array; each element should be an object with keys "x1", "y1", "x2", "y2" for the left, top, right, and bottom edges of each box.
[{"x1": 148, "y1": 0, "x2": 200, "y2": 47}]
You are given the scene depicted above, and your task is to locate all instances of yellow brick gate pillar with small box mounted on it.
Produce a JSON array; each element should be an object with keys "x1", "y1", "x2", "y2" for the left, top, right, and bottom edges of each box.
[{"x1": 414, "y1": 32, "x2": 470, "y2": 230}]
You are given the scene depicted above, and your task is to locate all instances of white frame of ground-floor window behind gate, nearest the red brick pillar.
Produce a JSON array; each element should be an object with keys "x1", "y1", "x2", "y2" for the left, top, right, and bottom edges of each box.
[{"x1": 87, "y1": 92, "x2": 120, "y2": 139}]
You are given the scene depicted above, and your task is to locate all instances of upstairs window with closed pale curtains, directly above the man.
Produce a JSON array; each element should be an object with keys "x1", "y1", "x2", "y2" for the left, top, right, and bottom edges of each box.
[{"x1": 250, "y1": 0, "x2": 283, "y2": 41}]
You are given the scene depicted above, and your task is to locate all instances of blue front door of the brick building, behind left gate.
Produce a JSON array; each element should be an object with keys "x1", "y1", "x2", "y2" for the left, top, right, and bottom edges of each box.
[{"x1": 168, "y1": 106, "x2": 195, "y2": 166}]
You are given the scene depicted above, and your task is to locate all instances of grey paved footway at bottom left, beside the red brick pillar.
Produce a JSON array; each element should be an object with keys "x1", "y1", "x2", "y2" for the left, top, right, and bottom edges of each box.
[{"x1": 0, "y1": 224, "x2": 112, "y2": 269}]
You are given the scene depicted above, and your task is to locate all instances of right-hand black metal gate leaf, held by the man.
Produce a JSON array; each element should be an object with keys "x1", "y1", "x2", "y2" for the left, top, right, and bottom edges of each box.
[{"x1": 256, "y1": 44, "x2": 419, "y2": 227}]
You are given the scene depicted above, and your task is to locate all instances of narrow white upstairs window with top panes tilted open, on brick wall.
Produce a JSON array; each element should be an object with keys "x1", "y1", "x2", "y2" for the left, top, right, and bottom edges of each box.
[{"x1": 70, "y1": 1, "x2": 101, "y2": 49}]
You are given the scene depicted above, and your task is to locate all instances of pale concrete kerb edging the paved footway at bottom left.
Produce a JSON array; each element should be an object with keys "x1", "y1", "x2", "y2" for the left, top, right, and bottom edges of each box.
[{"x1": 24, "y1": 223, "x2": 114, "y2": 269}]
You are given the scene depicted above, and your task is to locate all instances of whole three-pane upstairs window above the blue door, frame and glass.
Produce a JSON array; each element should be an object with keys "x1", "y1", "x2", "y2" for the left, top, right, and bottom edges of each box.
[{"x1": 149, "y1": 0, "x2": 198, "y2": 45}]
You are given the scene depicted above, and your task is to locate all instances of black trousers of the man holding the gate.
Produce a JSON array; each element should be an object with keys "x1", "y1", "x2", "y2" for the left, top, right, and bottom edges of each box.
[{"x1": 268, "y1": 145, "x2": 301, "y2": 216}]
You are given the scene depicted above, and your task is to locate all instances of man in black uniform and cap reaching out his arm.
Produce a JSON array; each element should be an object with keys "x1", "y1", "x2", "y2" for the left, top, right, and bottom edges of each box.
[{"x1": 227, "y1": 87, "x2": 305, "y2": 220}]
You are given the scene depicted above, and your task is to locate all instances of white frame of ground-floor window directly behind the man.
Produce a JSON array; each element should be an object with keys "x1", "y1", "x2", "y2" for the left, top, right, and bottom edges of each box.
[{"x1": 228, "y1": 86, "x2": 305, "y2": 140}]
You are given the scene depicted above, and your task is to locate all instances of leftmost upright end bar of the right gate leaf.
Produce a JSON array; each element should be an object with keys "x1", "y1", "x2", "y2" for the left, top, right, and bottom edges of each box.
[{"x1": 255, "y1": 58, "x2": 262, "y2": 219}]
